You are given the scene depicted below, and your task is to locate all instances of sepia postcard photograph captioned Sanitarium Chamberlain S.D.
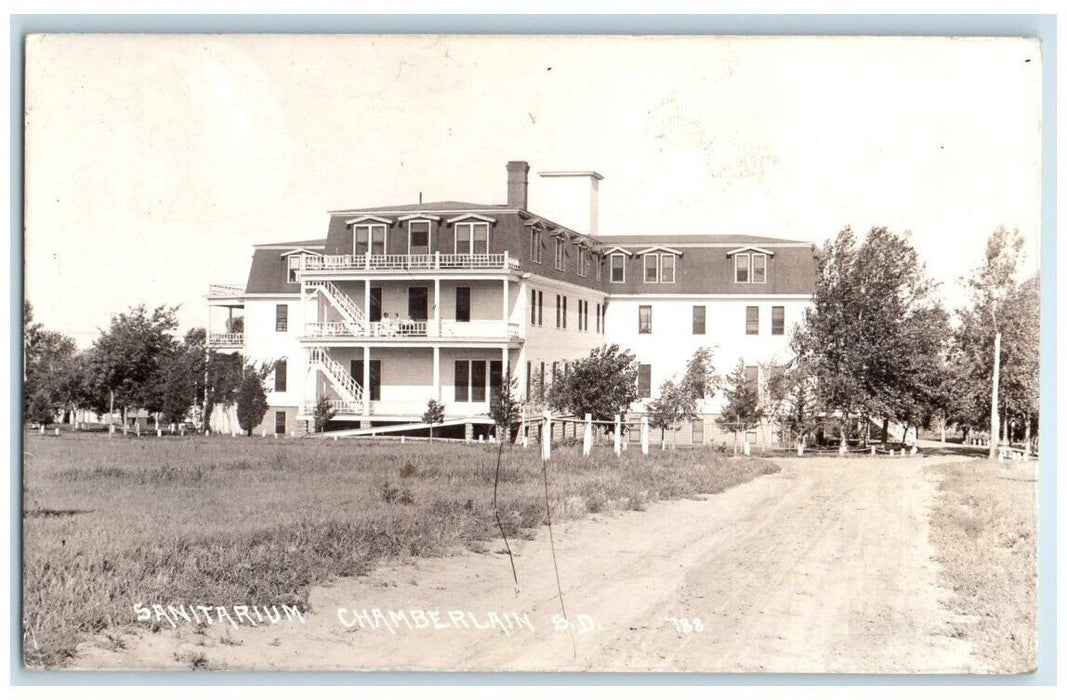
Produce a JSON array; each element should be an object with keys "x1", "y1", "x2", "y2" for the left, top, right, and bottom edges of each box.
[{"x1": 15, "y1": 33, "x2": 1053, "y2": 675}]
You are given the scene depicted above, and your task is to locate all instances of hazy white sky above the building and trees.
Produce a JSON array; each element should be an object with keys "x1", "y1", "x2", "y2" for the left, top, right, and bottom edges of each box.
[{"x1": 26, "y1": 35, "x2": 1040, "y2": 346}]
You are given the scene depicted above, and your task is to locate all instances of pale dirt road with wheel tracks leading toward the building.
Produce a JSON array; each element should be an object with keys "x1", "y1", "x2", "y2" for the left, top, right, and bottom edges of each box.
[{"x1": 76, "y1": 458, "x2": 982, "y2": 672}]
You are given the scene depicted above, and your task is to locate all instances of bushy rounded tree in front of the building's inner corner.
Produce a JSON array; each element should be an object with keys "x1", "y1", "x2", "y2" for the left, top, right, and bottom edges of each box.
[{"x1": 548, "y1": 345, "x2": 637, "y2": 420}]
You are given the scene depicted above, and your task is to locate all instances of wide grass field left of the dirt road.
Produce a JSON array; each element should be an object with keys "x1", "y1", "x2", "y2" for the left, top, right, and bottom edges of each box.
[{"x1": 22, "y1": 434, "x2": 778, "y2": 667}]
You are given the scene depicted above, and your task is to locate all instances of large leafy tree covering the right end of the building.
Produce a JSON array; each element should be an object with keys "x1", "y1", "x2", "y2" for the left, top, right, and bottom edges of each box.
[{"x1": 791, "y1": 227, "x2": 947, "y2": 448}]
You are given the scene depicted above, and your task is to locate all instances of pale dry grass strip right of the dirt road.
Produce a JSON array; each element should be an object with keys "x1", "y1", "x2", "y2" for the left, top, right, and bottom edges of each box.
[{"x1": 930, "y1": 461, "x2": 1037, "y2": 673}]
